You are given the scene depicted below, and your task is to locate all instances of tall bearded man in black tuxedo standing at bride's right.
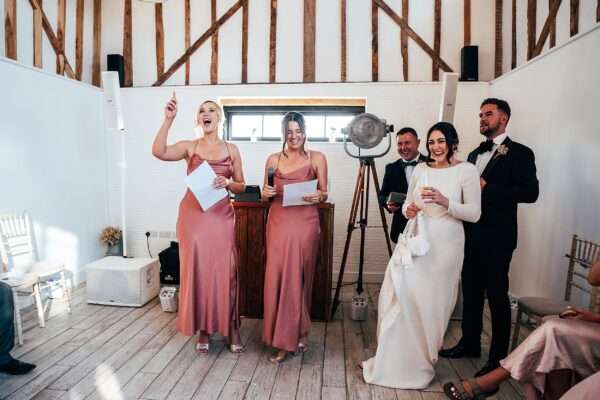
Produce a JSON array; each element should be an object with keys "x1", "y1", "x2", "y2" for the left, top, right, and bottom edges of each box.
[{"x1": 440, "y1": 98, "x2": 539, "y2": 376}]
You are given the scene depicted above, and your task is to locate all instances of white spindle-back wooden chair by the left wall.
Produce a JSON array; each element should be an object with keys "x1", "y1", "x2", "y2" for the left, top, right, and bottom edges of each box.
[{"x1": 0, "y1": 212, "x2": 71, "y2": 344}]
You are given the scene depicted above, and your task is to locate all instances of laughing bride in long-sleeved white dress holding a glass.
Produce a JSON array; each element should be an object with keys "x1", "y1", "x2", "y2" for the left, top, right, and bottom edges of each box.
[{"x1": 362, "y1": 122, "x2": 481, "y2": 389}]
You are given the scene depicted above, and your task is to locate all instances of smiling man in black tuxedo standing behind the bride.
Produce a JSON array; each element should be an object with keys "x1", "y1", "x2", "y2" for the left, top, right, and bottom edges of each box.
[{"x1": 379, "y1": 127, "x2": 425, "y2": 243}]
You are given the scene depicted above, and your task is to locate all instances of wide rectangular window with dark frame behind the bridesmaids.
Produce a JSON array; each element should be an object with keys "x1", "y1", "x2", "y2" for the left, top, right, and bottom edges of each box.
[{"x1": 223, "y1": 101, "x2": 365, "y2": 142}]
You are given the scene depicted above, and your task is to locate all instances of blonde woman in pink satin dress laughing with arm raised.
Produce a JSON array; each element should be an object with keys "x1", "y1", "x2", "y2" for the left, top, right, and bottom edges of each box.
[{"x1": 152, "y1": 93, "x2": 245, "y2": 353}]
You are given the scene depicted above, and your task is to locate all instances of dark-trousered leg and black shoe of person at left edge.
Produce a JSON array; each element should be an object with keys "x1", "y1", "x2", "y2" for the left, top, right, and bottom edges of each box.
[{"x1": 0, "y1": 282, "x2": 35, "y2": 375}]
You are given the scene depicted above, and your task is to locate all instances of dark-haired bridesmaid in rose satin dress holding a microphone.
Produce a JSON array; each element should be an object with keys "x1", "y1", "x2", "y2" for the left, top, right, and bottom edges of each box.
[{"x1": 262, "y1": 112, "x2": 327, "y2": 362}]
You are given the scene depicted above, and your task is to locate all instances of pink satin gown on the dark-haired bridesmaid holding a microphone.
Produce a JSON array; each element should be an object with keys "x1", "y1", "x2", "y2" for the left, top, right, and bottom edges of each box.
[{"x1": 263, "y1": 164, "x2": 320, "y2": 351}]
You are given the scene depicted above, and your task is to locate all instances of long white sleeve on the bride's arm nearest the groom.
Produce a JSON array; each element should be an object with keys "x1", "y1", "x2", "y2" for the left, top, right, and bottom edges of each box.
[{"x1": 448, "y1": 163, "x2": 481, "y2": 222}]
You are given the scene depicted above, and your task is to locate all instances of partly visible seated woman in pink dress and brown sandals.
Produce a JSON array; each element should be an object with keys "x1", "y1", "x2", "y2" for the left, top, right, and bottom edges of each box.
[{"x1": 444, "y1": 262, "x2": 600, "y2": 400}]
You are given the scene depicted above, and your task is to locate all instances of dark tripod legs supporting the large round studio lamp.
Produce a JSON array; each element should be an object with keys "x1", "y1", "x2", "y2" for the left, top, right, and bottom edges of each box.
[{"x1": 331, "y1": 157, "x2": 392, "y2": 317}]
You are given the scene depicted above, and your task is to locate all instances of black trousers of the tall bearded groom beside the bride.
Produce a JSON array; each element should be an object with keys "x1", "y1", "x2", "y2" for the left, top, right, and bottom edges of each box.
[{"x1": 461, "y1": 244, "x2": 513, "y2": 364}]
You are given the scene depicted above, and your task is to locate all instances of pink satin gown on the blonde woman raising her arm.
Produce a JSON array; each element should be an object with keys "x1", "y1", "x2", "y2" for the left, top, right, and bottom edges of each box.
[{"x1": 177, "y1": 154, "x2": 240, "y2": 337}]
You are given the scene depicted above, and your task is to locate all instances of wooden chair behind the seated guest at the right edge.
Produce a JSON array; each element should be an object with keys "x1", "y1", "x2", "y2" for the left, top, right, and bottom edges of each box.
[{"x1": 510, "y1": 235, "x2": 600, "y2": 351}]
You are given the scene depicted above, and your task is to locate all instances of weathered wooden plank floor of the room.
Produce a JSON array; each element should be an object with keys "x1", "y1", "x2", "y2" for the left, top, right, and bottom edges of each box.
[{"x1": 0, "y1": 284, "x2": 531, "y2": 400}]
